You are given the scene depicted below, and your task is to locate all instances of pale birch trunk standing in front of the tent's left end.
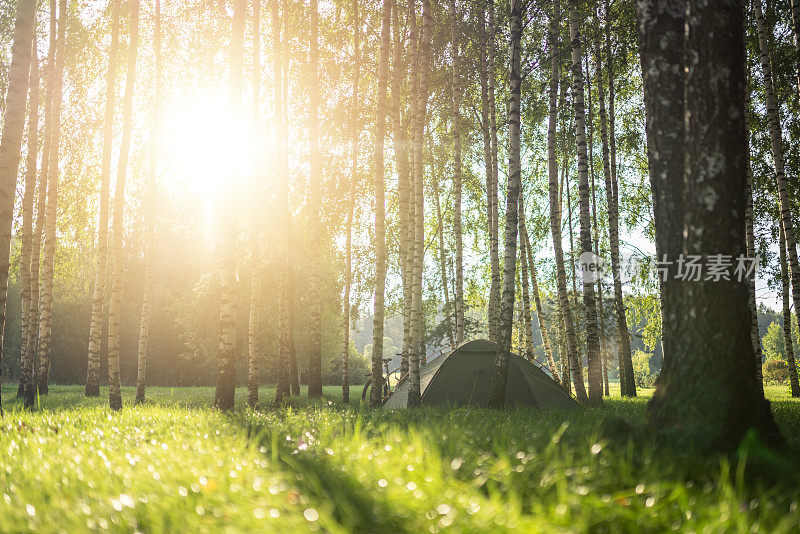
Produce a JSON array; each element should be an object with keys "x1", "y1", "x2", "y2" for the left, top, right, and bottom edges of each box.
[{"x1": 408, "y1": 0, "x2": 431, "y2": 408}]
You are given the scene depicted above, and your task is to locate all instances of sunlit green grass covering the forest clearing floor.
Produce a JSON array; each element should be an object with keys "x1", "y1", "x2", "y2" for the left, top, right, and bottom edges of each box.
[{"x1": 0, "y1": 386, "x2": 800, "y2": 532}]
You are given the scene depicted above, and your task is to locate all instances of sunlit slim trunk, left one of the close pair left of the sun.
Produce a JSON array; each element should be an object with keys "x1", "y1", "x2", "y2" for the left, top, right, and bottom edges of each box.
[{"x1": 85, "y1": 0, "x2": 120, "y2": 397}]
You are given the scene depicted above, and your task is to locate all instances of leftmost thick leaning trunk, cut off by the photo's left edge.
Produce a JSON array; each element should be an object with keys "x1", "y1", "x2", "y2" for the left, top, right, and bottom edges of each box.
[{"x1": 0, "y1": 0, "x2": 38, "y2": 406}]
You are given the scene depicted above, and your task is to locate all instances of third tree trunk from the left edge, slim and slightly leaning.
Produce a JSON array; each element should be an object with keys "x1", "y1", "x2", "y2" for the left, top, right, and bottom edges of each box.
[{"x1": 25, "y1": 0, "x2": 56, "y2": 408}]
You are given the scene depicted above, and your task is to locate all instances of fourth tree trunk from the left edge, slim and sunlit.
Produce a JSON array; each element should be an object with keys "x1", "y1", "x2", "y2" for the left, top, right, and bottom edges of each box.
[{"x1": 36, "y1": 0, "x2": 67, "y2": 395}]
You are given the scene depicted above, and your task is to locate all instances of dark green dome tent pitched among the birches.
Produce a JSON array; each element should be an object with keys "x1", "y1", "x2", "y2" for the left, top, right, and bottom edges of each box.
[{"x1": 383, "y1": 339, "x2": 578, "y2": 408}]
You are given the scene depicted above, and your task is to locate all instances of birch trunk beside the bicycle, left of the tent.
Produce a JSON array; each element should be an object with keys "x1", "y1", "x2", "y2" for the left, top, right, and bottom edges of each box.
[{"x1": 369, "y1": 0, "x2": 392, "y2": 408}]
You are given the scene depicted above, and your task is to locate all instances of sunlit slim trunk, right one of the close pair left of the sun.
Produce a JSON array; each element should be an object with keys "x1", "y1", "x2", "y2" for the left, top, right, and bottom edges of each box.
[{"x1": 108, "y1": 0, "x2": 139, "y2": 410}]
